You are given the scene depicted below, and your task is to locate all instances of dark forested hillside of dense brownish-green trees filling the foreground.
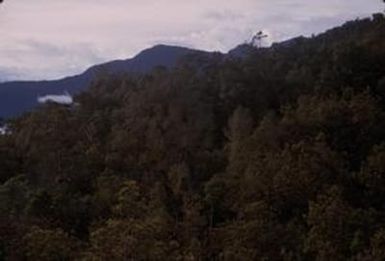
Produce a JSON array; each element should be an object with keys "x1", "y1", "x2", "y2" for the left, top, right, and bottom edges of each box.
[{"x1": 0, "y1": 14, "x2": 385, "y2": 261}]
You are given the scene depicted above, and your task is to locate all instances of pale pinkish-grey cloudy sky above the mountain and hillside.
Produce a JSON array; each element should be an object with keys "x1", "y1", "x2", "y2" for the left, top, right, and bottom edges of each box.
[{"x1": 0, "y1": 0, "x2": 384, "y2": 81}]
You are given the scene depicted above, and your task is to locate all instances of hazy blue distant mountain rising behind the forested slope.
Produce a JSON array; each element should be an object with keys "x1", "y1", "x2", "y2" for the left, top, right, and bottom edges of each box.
[{"x1": 0, "y1": 45, "x2": 208, "y2": 118}]
